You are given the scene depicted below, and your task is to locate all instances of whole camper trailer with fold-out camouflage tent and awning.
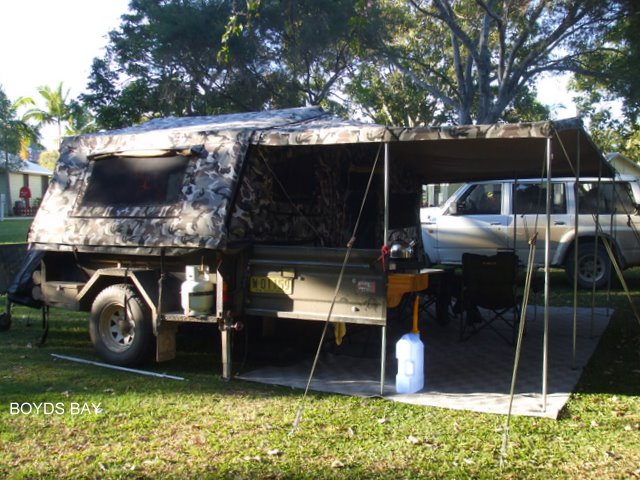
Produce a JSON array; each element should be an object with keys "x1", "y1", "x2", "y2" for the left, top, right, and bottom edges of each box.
[{"x1": 3, "y1": 108, "x2": 606, "y2": 378}]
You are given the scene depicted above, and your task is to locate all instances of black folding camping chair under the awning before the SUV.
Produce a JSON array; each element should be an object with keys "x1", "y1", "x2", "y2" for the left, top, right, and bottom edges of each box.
[{"x1": 460, "y1": 252, "x2": 522, "y2": 345}]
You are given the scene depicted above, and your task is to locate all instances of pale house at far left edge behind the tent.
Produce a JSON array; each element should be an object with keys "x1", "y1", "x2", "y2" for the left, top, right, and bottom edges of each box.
[{"x1": 0, "y1": 152, "x2": 53, "y2": 216}]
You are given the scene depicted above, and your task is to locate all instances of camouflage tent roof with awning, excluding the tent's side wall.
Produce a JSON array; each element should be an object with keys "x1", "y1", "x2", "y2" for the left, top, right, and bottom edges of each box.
[{"x1": 80, "y1": 107, "x2": 614, "y2": 183}]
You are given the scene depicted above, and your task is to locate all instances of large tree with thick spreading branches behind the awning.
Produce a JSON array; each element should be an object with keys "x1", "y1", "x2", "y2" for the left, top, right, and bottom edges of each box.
[{"x1": 378, "y1": 0, "x2": 622, "y2": 123}]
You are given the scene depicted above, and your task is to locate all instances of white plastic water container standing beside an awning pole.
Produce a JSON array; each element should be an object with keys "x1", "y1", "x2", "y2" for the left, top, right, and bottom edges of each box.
[{"x1": 396, "y1": 333, "x2": 424, "y2": 393}]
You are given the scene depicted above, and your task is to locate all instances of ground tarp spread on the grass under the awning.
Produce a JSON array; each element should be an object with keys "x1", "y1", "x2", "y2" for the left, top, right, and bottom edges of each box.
[{"x1": 238, "y1": 307, "x2": 613, "y2": 418}]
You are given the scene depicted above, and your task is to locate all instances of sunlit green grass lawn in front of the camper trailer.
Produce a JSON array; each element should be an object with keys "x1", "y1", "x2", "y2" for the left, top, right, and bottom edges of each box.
[{"x1": 0, "y1": 271, "x2": 640, "y2": 479}]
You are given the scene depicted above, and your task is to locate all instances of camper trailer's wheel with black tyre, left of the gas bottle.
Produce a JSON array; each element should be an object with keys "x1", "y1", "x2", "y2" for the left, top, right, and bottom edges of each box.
[{"x1": 89, "y1": 284, "x2": 155, "y2": 366}]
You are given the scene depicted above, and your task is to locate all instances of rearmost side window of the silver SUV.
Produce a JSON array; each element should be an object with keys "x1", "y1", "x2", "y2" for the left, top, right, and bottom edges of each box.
[{"x1": 578, "y1": 182, "x2": 635, "y2": 214}]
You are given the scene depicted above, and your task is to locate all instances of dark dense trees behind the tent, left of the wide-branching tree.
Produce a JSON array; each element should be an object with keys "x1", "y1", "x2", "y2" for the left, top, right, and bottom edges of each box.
[{"x1": 82, "y1": 0, "x2": 383, "y2": 128}]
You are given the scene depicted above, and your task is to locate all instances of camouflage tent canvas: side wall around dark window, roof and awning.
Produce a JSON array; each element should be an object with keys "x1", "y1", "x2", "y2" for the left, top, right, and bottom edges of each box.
[{"x1": 29, "y1": 108, "x2": 611, "y2": 252}]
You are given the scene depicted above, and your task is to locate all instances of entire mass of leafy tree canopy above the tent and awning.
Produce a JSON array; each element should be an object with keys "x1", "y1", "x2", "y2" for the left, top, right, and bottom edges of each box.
[{"x1": 71, "y1": 0, "x2": 640, "y2": 158}]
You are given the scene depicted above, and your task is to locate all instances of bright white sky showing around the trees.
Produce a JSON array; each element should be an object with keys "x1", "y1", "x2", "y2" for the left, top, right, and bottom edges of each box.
[{"x1": 0, "y1": 0, "x2": 575, "y2": 149}]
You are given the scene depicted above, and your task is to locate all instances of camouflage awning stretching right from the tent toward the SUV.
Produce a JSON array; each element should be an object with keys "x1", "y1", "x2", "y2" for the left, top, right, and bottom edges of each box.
[{"x1": 252, "y1": 113, "x2": 614, "y2": 183}]
